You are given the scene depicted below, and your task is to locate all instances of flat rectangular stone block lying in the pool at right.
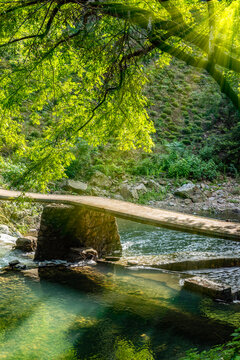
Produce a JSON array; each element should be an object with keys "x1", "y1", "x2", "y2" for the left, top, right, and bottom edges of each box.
[{"x1": 183, "y1": 276, "x2": 233, "y2": 302}]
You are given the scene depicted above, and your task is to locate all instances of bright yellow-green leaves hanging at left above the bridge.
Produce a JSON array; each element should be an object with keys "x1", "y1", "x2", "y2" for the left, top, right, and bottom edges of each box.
[{"x1": 0, "y1": 5, "x2": 157, "y2": 190}]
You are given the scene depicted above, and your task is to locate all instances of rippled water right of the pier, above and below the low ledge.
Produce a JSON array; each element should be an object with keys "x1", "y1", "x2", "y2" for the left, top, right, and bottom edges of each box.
[{"x1": 118, "y1": 220, "x2": 240, "y2": 291}]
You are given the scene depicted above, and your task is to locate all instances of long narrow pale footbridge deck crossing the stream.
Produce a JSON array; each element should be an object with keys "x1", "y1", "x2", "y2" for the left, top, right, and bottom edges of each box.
[{"x1": 0, "y1": 189, "x2": 240, "y2": 241}]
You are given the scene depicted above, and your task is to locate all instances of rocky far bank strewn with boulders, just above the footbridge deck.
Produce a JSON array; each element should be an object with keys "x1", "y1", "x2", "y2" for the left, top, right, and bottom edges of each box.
[{"x1": 53, "y1": 171, "x2": 240, "y2": 222}]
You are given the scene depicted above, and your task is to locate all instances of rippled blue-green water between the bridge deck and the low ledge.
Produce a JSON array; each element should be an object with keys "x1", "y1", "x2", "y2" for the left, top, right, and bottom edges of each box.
[{"x1": 118, "y1": 220, "x2": 240, "y2": 257}]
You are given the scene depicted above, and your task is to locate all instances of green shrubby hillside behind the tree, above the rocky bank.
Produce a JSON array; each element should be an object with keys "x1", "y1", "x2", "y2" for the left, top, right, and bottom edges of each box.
[{"x1": 60, "y1": 60, "x2": 240, "y2": 187}]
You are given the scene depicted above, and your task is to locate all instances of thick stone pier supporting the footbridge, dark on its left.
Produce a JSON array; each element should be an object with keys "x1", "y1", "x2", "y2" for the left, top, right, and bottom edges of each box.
[{"x1": 35, "y1": 204, "x2": 122, "y2": 261}]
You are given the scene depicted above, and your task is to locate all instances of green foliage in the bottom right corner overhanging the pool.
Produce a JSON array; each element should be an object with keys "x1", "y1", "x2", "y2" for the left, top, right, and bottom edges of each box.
[{"x1": 181, "y1": 329, "x2": 240, "y2": 360}]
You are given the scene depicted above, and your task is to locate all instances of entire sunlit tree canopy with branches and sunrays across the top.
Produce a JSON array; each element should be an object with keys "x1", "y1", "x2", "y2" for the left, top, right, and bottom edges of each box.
[{"x1": 0, "y1": 0, "x2": 240, "y2": 189}]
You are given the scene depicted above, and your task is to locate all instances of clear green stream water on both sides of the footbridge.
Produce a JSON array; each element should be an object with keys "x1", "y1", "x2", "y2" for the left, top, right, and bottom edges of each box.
[{"x1": 0, "y1": 223, "x2": 240, "y2": 360}]
